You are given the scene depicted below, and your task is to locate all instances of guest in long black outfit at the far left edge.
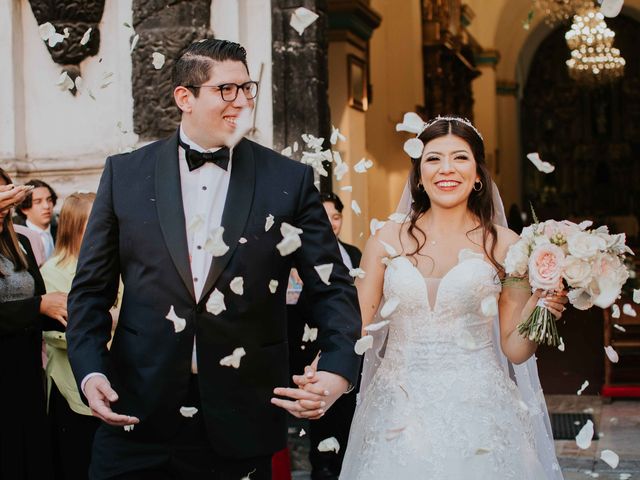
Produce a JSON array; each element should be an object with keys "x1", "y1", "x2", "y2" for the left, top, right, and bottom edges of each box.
[{"x1": 0, "y1": 168, "x2": 67, "y2": 480}]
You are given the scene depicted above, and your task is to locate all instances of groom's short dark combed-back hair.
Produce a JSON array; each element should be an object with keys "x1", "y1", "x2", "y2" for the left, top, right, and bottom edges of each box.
[{"x1": 171, "y1": 38, "x2": 249, "y2": 97}]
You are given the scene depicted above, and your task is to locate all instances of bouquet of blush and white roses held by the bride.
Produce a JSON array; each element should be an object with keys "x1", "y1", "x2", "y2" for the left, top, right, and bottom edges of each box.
[{"x1": 505, "y1": 215, "x2": 633, "y2": 346}]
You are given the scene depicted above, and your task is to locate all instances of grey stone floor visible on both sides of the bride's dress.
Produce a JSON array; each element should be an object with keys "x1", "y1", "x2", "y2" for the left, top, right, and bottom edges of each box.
[{"x1": 290, "y1": 395, "x2": 640, "y2": 480}]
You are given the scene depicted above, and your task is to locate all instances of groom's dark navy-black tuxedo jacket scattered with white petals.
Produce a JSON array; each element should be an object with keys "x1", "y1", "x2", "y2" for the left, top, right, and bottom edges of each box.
[{"x1": 67, "y1": 133, "x2": 361, "y2": 457}]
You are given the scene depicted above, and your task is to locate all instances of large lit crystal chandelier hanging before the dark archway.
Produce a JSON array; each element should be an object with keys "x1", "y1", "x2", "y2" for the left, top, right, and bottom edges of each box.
[{"x1": 565, "y1": 7, "x2": 625, "y2": 84}]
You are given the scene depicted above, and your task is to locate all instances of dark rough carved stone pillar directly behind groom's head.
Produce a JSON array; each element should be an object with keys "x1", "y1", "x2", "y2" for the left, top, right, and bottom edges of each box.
[{"x1": 132, "y1": 0, "x2": 212, "y2": 140}]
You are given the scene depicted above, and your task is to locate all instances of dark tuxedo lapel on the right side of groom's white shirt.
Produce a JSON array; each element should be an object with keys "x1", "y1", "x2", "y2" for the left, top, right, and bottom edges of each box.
[{"x1": 202, "y1": 139, "x2": 256, "y2": 298}]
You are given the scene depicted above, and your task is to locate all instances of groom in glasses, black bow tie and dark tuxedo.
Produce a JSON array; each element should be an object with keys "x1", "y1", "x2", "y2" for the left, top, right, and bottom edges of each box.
[{"x1": 67, "y1": 40, "x2": 361, "y2": 480}]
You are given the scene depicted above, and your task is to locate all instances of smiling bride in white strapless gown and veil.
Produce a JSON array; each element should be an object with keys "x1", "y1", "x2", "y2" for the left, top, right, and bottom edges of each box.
[{"x1": 299, "y1": 117, "x2": 566, "y2": 480}]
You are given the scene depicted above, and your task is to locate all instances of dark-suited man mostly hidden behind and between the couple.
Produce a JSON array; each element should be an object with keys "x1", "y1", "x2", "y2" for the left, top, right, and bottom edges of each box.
[{"x1": 288, "y1": 192, "x2": 362, "y2": 480}]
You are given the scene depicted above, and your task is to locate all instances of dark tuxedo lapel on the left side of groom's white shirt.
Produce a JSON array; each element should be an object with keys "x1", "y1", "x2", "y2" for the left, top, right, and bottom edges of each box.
[{"x1": 155, "y1": 131, "x2": 195, "y2": 300}]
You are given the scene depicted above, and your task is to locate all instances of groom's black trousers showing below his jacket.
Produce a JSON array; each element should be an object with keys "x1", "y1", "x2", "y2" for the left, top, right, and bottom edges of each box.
[{"x1": 89, "y1": 375, "x2": 271, "y2": 480}]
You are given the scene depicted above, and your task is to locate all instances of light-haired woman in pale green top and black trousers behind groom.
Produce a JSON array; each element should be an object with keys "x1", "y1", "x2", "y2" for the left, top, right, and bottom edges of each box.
[{"x1": 40, "y1": 193, "x2": 100, "y2": 480}]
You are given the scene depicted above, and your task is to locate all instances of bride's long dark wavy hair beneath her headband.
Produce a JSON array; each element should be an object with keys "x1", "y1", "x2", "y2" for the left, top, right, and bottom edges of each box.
[{"x1": 408, "y1": 119, "x2": 504, "y2": 274}]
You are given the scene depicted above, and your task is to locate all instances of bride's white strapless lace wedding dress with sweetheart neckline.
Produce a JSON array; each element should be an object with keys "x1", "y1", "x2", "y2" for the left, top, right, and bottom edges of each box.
[{"x1": 340, "y1": 249, "x2": 562, "y2": 480}]
